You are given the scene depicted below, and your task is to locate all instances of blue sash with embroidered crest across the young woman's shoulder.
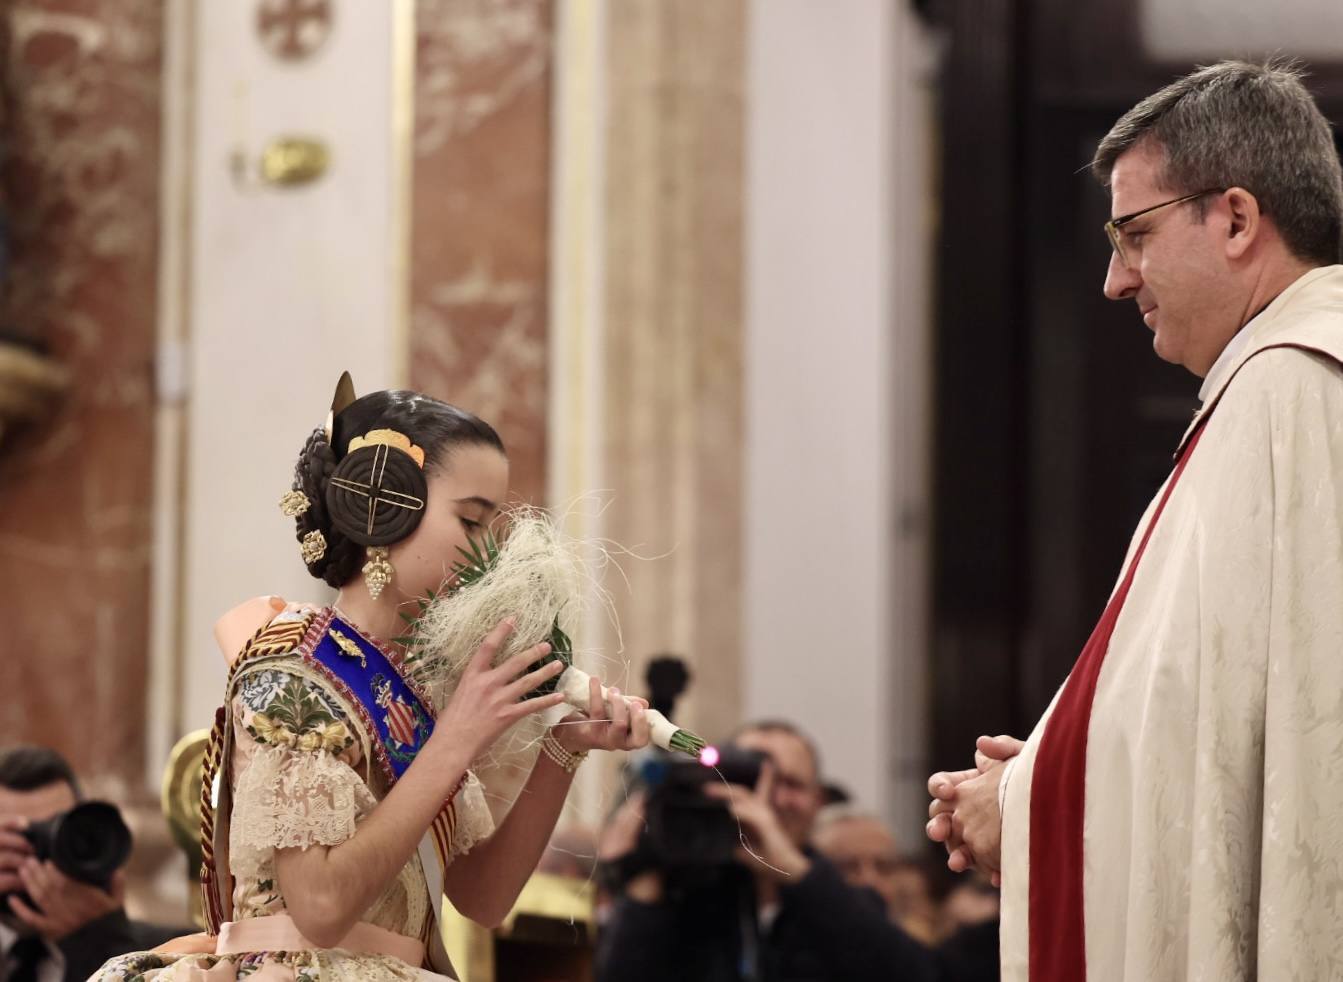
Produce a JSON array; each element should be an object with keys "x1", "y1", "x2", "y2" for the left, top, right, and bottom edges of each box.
[{"x1": 304, "y1": 611, "x2": 434, "y2": 785}]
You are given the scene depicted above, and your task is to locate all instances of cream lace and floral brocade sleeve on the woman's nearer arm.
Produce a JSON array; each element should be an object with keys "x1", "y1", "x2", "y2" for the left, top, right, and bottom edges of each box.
[{"x1": 230, "y1": 669, "x2": 376, "y2": 858}]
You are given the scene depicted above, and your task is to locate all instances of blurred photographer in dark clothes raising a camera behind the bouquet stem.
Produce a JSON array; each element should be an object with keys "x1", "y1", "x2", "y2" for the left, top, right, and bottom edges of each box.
[{"x1": 596, "y1": 721, "x2": 933, "y2": 982}]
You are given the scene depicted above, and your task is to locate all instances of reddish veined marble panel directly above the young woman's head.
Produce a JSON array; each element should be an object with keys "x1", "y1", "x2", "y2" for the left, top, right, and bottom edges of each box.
[{"x1": 410, "y1": 0, "x2": 552, "y2": 504}]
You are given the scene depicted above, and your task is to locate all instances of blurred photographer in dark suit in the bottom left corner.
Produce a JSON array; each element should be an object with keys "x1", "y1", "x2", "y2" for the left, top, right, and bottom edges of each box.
[{"x1": 0, "y1": 747, "x2": 161, "y2": 982}]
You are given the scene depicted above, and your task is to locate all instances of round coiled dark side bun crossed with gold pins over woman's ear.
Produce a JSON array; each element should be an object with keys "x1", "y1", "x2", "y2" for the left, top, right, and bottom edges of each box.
[{"x1": 326, "y1": 443, "x2": 428, "y2": 545}]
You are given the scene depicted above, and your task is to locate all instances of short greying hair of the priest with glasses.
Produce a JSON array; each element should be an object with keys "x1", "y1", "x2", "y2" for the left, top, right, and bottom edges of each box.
[{"x1": 1091, "y1": 59, "x2": 1343, "y2": 266}]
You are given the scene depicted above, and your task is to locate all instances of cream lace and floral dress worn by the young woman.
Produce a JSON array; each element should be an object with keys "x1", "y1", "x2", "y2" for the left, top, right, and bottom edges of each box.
[{"x1": 93, "y1": 614, "x2": 494, "y2": 982}]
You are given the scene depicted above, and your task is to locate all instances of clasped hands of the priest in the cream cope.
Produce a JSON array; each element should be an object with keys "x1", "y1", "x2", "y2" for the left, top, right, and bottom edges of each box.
[{"x1": 927, "y1": 736, "x2": 1025, "y2": 887}]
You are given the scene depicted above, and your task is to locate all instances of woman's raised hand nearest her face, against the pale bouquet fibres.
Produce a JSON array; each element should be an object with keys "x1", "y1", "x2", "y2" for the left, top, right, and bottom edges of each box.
[{"x1": 428, "y1": 618, "x2": 564, "y2": 760}]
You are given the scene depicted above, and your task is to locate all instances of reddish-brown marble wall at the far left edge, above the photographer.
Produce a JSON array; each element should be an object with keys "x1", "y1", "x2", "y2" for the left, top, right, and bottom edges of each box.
[{"x1": 0, "y1": 0, "x2": 163, "y2": 787}]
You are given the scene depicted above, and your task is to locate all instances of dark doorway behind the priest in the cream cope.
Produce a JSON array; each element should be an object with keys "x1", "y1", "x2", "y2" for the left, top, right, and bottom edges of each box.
[{"x1": 925, "y1": 0, "x2": 1343, "y2": 767}]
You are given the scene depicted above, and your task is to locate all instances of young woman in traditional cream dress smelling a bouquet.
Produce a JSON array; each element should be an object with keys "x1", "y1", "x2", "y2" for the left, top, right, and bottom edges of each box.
[{"x1": 95, "y1": 376, "x2": 649, "y2": 982}]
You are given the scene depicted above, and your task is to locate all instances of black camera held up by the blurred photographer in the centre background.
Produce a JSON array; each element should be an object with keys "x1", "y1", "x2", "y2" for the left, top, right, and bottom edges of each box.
[{"x1": 641, "y1": 746, "x2": 764, "y2": 869}]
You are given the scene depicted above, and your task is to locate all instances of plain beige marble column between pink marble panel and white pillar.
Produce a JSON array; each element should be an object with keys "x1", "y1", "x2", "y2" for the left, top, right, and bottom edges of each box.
[{"x1": 600, "y1": 0, "x2": 747, "y2": 739}]
